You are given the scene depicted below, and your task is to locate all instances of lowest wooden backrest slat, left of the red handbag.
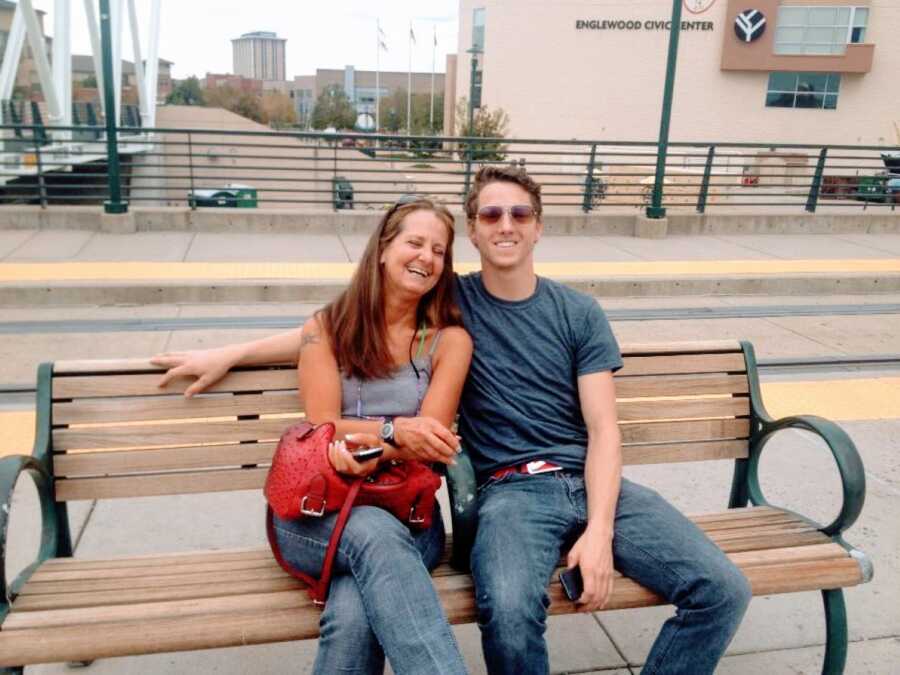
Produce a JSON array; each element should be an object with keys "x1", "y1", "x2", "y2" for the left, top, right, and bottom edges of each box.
[{"x1": 56, "y1": 468, "x2": 269, "y2": 502}]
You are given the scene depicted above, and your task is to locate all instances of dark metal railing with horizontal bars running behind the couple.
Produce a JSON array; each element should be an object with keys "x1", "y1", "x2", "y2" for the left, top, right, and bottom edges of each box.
[{"x1": 0, "y1": 125, "x2": 900, "y2": 213}]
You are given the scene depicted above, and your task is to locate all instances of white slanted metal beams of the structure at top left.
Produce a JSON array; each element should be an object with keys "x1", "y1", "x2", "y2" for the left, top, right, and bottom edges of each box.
[{"x1": 0, "y1": 0, "x2": 161, "y2": 128}]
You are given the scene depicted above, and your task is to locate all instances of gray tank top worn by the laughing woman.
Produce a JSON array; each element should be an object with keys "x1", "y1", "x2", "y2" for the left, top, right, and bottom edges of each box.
[{"x1": 341, "y1": 331, "x2": 441, "y2": 418}]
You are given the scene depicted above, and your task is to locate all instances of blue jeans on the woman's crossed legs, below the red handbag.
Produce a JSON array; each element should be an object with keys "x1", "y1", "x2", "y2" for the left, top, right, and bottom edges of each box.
[{"x1": 275, "y1": 506, "x2": 466, "y2": 675}]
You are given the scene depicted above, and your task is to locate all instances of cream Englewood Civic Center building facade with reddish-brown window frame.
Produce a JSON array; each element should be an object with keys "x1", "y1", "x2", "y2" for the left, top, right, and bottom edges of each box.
[{"x1": 454, "y1": 0, "x2": 900, "y2": 145}]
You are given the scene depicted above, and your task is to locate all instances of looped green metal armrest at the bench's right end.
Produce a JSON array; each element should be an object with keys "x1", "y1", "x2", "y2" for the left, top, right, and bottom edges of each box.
[{"x1": 747, "y1": 415, "x2": 866, "y2": 537}]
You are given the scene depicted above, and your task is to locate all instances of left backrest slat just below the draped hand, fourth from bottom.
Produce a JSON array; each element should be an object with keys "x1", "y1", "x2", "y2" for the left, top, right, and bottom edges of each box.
[{"x1": 53, "y1": 389, "x2": 302, "y2": 424}]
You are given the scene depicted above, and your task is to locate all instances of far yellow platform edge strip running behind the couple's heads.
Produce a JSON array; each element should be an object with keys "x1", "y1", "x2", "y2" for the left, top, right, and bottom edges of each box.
[{"x1": 0, "y1": 258, "x2": 900, "y2": 283}]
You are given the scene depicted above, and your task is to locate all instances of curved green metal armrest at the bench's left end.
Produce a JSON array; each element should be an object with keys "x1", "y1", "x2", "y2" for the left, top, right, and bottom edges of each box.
[{"x1": 0, "y1": 455, "x2": 57, "y2": 620}]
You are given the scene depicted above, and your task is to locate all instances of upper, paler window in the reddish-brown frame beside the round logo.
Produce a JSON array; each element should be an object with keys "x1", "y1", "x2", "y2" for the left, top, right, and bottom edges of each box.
[{"x1": 775, "y1": 5, "x2": 869, "y2": 54}]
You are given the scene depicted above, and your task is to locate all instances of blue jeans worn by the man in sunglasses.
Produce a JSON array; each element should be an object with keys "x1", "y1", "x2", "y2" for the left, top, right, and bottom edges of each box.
[{"x1": 472, "y1": 472, "x2": 751, "y2": 675}]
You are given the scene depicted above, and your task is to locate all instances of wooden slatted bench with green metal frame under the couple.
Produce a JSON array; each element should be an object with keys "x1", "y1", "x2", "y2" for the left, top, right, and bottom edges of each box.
[{"x1": 0, "y1": 342, "x2": 872, "y2": 672}]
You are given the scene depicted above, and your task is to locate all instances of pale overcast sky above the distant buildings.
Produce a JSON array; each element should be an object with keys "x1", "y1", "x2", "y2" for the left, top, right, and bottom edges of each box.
[{"x1": 34, "y1": 0, "x2": 459, "y2": 79}]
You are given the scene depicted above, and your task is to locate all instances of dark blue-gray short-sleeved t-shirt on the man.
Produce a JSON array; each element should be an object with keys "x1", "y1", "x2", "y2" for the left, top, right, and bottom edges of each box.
[{"x1": 457, "y1": 273, "x2": 622, "y2": 482}]
